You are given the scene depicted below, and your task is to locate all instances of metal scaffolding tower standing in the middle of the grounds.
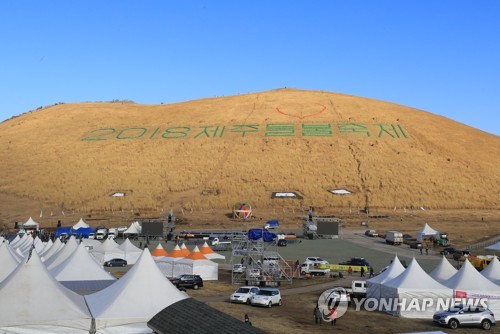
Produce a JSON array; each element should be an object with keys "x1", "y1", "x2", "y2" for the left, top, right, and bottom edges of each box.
[{"x1": 231, "y1": 232, "x2": 293, "y2": 286}]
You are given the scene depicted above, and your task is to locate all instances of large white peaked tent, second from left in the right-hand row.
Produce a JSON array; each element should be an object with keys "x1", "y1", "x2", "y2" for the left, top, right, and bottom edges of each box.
[{"x1": 380, "y1": 259, "x2": 453, "y2": 319}]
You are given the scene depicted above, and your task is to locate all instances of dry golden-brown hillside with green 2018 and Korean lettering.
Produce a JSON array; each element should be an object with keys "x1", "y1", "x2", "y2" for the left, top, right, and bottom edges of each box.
[{"x1": 0, "y1": 89, "x2": 500, "y2": 219}]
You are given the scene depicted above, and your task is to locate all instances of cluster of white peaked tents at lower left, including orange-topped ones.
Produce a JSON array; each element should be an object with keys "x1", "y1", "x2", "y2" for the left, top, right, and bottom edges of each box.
[{"x1": 0, "y1": 236, "x2": 229, "y2": 334}]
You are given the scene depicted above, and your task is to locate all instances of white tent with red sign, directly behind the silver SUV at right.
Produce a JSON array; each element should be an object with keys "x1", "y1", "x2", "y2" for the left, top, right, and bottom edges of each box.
[{"x1": 443, "y1": 261, "x2": 500, "y2": 320}]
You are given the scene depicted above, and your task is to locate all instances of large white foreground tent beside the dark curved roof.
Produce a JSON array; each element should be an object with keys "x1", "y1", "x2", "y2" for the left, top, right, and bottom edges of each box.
[{"x1": 85, "y1": 248, "x2": 188, "y2": 334}]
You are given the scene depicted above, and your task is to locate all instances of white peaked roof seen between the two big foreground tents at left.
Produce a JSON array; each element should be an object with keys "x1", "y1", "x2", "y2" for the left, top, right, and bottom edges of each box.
[{"x1": 49, "y1": 244, "x2": 115, "y2": 282}]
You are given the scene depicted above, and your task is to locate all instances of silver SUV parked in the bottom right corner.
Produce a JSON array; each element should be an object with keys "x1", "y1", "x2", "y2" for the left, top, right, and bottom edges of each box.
[{"x1": 433, "y1": 305, "x2": 496, "y2": 329}]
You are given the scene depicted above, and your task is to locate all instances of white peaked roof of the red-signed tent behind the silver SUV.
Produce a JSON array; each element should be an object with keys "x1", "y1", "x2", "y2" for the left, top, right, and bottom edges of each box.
[{"x1": 443, "y1": 261, "x2": 500, "y2": 292}]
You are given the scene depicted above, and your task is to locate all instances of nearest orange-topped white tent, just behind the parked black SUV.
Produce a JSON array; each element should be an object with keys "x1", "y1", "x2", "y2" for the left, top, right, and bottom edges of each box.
[{"x1": 173, "y1": 246, "x2": 219, "y2": 281}]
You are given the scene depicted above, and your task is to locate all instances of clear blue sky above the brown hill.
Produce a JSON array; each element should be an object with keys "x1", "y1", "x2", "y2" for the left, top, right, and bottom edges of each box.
[{"x1": 0, "y1": 0, "x2": 500, "y2": 136}]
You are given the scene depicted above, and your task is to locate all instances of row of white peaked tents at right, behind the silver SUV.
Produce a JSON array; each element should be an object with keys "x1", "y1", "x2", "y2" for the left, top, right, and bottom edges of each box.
[{"x1": 366, "y1": 256, "x2": 500, "y2": 319}]
